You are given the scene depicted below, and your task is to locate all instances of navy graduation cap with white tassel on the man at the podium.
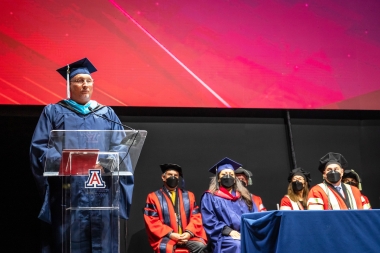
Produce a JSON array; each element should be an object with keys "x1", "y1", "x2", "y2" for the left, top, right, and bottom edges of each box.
[{"x1": 57, "y1": 58, "x2": 97, "y2": 98}]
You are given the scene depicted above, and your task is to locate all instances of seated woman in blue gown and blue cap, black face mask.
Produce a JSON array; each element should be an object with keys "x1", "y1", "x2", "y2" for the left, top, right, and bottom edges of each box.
[{"x1": 201, "y1": 157, "x2": 258, "y2": 253}]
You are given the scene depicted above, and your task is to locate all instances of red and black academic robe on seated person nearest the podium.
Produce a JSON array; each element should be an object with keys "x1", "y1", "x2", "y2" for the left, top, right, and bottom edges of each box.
[{"x1": 144, "y1": 188, "x2": 207, "y2": 253}]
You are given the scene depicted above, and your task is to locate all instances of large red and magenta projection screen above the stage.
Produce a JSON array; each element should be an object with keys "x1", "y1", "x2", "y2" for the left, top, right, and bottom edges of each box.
[{"x1": 0, "y1": 0, "x2": 380, "y2": 110}]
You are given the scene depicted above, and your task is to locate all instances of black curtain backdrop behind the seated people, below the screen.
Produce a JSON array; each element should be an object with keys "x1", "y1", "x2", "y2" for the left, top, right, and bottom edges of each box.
[{"x1": 0, "y1": 106, "x2": 380, "y2": 252}]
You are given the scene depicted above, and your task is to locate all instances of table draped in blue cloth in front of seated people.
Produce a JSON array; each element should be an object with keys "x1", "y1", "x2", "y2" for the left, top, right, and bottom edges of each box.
[{"x1": 241, "y1": 210, "x2": 380, "y2": 253}]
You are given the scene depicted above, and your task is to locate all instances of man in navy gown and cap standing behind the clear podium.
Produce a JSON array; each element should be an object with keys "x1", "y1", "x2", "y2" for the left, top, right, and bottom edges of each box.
[{"x1": 30, "y1": 58, "x2": 133, "y2": 253}]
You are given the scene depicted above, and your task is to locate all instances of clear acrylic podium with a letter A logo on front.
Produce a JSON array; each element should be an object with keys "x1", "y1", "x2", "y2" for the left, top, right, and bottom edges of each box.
[{"x1": 44, "y1": 130, "x2": 147, "y2": 253}]
